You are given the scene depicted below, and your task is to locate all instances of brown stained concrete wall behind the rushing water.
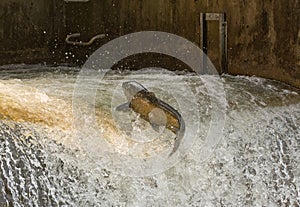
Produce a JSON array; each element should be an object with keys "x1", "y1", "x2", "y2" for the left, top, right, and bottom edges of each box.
[{"x1": 0, "y1": 0, "x2": 300, "y2": 87}]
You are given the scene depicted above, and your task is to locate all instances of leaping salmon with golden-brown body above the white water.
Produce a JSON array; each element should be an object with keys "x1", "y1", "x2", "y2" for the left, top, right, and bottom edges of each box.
[{"x1": 116, "y1": 81, "x2": 185, "y2": 157}]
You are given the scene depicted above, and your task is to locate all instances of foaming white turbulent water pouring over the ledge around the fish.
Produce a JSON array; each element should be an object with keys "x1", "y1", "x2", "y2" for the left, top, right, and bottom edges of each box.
[{"x1": 0, "y1": 65, "x2": 300, "y2": 207}]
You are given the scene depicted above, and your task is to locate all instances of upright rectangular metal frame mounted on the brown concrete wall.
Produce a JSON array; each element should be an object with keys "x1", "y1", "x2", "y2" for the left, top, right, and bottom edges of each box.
[{"x1": 200, "y1": 13, "x2": 227, "y2": 73}]
